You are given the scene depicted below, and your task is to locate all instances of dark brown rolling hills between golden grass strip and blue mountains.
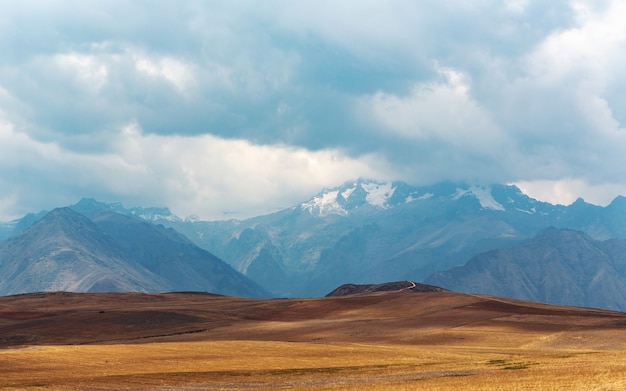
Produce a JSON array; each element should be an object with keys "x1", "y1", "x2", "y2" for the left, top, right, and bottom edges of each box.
[{"x1": 0, "y1": 289, "x2": 626, "y2": 349}]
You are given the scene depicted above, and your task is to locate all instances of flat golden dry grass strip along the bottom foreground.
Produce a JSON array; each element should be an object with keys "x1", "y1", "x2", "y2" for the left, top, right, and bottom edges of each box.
[{"x1": 0, "y1": 341, "x2": 626, "y2": 390}]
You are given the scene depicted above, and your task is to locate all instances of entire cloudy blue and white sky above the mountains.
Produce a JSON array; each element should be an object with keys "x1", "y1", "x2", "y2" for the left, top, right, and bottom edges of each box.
[{"x1": 0, "y1": 0, "x2": 626, "y2": 221}]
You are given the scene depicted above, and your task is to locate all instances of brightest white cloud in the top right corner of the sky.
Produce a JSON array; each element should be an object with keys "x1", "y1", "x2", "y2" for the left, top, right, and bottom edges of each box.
[{"x1": 524, "y1": 1, "x2": 626, "y2": 133}]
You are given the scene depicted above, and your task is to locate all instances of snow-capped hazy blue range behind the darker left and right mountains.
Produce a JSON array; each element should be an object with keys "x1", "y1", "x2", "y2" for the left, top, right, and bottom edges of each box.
[{"x1": 3, "y1": 180, "x2": 626, "y2": 296}]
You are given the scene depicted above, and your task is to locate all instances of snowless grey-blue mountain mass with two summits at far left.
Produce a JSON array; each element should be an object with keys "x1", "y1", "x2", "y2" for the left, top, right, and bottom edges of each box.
[{"x1": 0, "y1": 208, "x2": 267, "y2": 296}]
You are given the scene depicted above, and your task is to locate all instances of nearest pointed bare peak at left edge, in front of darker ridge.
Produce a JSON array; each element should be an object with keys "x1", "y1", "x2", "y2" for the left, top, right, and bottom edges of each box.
[{"x1": 0, "y1": 208, "x2": 162, "y2": 295}]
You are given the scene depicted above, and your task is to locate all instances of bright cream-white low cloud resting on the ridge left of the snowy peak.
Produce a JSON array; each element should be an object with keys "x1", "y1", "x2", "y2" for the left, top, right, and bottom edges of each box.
[{"x1": 119, "y1": 124, "x2": 387, "y2": 218}]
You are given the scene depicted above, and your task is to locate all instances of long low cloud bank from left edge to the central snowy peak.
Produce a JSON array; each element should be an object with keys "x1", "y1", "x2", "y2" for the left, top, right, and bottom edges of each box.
[{"x1": 0, "y1": 119, "x2": 389, "y2": 220}]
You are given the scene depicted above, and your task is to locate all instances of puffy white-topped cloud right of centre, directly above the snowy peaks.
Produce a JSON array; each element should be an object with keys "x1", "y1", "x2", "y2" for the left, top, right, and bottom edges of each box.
[{"x1": 356, "y1": 64, "x2": 513, "y2": 183}]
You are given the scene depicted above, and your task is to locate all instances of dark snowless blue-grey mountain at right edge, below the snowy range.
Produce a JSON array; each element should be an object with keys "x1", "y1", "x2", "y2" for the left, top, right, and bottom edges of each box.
[{"x1": 426, "y1": 228, "x2": 626, "y2": 311}]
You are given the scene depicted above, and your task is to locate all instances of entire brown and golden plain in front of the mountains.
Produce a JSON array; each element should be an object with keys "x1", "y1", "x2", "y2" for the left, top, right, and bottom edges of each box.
[{"x1": 0, "y1": 290, "x2": 626, "y2": 390}]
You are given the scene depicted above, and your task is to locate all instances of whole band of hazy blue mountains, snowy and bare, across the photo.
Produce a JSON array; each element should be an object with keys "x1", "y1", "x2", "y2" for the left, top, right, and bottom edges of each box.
[{"x1": 0, "y1": 180, "x2": 626, "y2": 310}]
